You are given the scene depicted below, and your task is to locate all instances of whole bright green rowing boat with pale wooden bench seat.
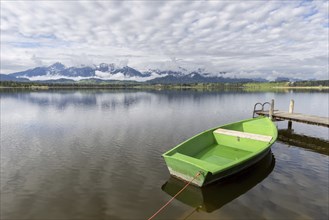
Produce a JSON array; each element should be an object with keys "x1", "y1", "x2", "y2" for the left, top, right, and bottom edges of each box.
[{"x1": 162, "y1": 117, "x2": 278, "y2": 187}]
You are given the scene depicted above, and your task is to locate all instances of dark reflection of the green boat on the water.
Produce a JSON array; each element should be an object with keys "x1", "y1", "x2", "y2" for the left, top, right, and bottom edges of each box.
[{"x1": 162, "y1": 151, "x2": 275, "y2": 212}]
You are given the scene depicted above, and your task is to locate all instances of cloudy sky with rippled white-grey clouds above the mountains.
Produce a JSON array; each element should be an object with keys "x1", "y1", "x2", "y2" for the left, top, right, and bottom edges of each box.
[{"x1": 1, "y1": 0, "x2": 329, "y2": 79}]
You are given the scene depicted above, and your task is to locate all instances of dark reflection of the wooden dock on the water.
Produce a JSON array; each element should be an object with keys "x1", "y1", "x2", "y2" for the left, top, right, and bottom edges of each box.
[{"x1": 278, "y1": 129, "x2": 329, "y2": 155}]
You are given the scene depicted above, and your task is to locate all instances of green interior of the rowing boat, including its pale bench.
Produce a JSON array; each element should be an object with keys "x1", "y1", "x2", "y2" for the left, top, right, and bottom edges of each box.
[{"x1": 165, "y1": 117, "x2": 273, "y2": 170}]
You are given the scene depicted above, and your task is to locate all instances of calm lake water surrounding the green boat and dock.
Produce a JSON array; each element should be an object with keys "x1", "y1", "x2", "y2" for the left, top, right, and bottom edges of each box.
[{"x1": 0, "y1": 90, "x2": 329, "y2": 219}]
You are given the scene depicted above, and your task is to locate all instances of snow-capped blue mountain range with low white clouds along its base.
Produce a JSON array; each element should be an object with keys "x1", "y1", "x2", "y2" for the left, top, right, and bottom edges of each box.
[{"x1": 0, "y1": 62, "x2": 266, "y2": 84}]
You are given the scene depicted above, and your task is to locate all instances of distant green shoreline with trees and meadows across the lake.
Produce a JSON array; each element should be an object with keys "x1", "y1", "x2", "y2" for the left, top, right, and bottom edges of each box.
[{"x1": 0, "y1": 80, "x2": 329, "y2": 91}]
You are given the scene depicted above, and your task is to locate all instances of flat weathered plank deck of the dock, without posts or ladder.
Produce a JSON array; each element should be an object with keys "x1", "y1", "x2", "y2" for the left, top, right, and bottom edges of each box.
[{"x1": 256, "y1": 111, "x2": 329, "y2": 127}]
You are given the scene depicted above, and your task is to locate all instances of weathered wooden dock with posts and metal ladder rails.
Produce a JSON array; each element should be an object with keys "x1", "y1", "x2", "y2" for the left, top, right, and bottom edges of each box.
[{"x1": 253, "y1": 99, "x2": 329, "y2": 129}]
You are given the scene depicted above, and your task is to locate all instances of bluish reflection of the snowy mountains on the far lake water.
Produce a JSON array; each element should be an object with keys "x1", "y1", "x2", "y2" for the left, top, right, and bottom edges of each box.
[{"x1": 0, "y1": 90, "x2": 246, "y2": 110}]
